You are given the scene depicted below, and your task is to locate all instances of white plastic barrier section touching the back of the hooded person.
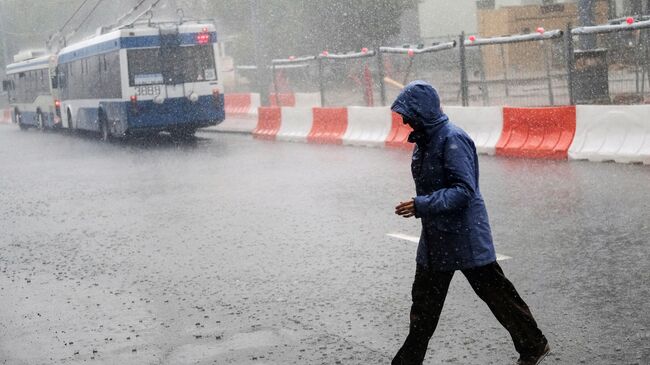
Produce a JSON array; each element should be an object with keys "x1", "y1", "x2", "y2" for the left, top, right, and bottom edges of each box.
[{"x1": 444, "y1": 106, "x2": 503, "y2": 155}]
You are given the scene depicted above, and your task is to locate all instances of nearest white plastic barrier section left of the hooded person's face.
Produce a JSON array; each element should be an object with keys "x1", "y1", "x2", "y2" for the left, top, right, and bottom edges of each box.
[{"x1": 343, "y1": 106, "x2": 392, "y2": 146}]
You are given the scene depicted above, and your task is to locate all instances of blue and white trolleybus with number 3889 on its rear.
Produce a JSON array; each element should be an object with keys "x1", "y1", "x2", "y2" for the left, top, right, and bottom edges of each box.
[{"x1": 53, "y1": 22, "x2": 225, "y2": 140}]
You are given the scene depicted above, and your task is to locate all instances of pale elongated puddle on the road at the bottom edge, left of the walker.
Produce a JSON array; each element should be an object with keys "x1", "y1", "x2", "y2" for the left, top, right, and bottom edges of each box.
[{"x1": 165, "y1": 328, "x2": 305, "y2": 365}]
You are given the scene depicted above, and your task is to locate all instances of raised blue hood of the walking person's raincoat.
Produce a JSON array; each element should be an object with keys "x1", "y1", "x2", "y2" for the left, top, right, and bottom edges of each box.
[{"x1": 391, "y1": 80, "x2": 449, "y2": 134}]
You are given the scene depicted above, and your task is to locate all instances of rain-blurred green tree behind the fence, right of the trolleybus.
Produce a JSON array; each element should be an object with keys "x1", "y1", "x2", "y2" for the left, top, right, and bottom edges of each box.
[{"x1": 205, "y1": 0, "x2": 414, "y2": 63}]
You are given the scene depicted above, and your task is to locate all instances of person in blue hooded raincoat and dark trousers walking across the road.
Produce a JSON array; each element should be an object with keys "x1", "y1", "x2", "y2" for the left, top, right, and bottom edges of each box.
[{"x1": 391, "y1": 81, "x2": 550, "y2": 365}]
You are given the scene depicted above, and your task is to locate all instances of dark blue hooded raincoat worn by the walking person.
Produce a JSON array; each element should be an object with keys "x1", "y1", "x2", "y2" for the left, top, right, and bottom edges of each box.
[{"x1": 391, "y1": 81, "x2": 496, "y2": 271}]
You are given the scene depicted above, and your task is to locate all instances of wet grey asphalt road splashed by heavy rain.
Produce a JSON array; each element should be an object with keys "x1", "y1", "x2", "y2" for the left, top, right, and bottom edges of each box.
[{"x1": 0, "y1": 125, "x2": 650, "y2": 365}]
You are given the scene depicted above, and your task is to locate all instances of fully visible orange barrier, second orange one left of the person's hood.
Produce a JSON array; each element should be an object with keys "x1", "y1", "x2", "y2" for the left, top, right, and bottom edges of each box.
[{"x1": 307, "y1": 108, "x2": 348, "y2": 144}]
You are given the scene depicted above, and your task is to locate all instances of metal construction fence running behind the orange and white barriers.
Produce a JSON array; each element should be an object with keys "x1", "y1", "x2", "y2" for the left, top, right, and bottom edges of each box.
[{"x1": 236, "y1": 18, "x2": 650, "y2": 106}]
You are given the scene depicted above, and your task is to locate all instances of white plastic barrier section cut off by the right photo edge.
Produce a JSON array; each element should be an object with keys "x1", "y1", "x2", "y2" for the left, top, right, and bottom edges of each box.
[{"x1": 569, "y1": 105, "x2": 650, "y2": 164}]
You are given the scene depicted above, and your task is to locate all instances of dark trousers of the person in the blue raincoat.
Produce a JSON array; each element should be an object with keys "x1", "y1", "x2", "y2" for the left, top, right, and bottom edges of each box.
[{"x1": 392, "y1": 262, "x2": 546, "y2": 365}]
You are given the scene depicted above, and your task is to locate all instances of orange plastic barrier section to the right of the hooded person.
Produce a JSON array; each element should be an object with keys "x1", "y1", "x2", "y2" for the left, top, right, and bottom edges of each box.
[{"x1": 496, "y1": 106, "x2": 576, "y2": 160}]
